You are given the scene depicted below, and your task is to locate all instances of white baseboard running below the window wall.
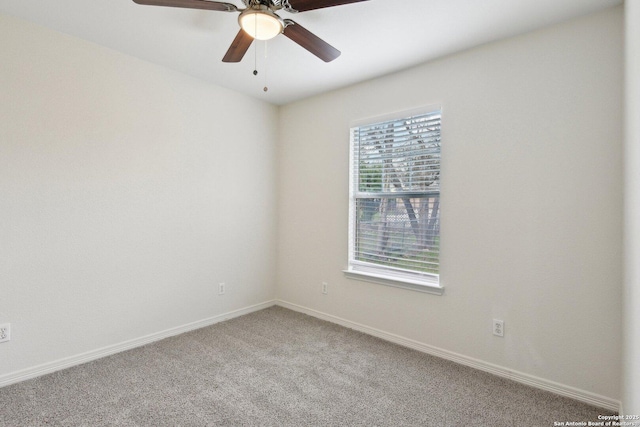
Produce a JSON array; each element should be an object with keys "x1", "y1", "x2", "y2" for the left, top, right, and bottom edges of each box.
[{"x1": 276, "y1": 300, "x2": 621, "y2": 412}]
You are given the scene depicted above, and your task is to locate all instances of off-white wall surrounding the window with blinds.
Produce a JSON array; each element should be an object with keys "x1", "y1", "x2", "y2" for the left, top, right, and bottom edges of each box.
[{"x1": 278, "y1": 7, "x2": 623, "y2": 400}]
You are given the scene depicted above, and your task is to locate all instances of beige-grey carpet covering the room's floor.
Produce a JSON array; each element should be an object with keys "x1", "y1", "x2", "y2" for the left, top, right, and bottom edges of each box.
[{"x1": 0, "y1": 307, "x2": 610, "y2": 427}]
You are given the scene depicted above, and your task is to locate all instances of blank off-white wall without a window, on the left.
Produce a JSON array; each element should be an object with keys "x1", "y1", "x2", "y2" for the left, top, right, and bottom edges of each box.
[{"x1": 0, "y1": 16, "x2": 278, "y2": 376}]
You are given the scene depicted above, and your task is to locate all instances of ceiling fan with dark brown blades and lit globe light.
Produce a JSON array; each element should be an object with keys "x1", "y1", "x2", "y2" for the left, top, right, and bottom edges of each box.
[{"x1": 133, "y1": 0, "x2": 367, "y2": 62}]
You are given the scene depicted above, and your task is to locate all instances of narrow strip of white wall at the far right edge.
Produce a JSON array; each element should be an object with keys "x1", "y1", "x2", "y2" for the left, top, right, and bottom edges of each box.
[{"x1": 622, "y1": 0, "x2": 640, "y2": 415}]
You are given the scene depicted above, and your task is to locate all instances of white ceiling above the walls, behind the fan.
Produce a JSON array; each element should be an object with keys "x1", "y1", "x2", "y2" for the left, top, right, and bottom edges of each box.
[{"x1": 0, "y1": 0, "x2": 622, "y2": 104}]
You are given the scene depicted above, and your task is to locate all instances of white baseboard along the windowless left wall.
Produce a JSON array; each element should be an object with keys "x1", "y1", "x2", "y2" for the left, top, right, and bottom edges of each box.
[{"x1": 0, "y1": 300, "x2": 276, "y2": 387}]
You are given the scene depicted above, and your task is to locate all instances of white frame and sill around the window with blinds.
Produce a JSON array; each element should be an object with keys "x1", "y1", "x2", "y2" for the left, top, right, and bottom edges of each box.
[{"x1": 343, "y1": 105, "x2": 444, "y2": 295}]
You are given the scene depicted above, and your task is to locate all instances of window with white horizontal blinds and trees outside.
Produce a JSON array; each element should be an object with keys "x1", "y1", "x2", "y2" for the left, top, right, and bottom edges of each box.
[{"x1": 345, "y1": 110, "x2": 442, "y2": 294}]
